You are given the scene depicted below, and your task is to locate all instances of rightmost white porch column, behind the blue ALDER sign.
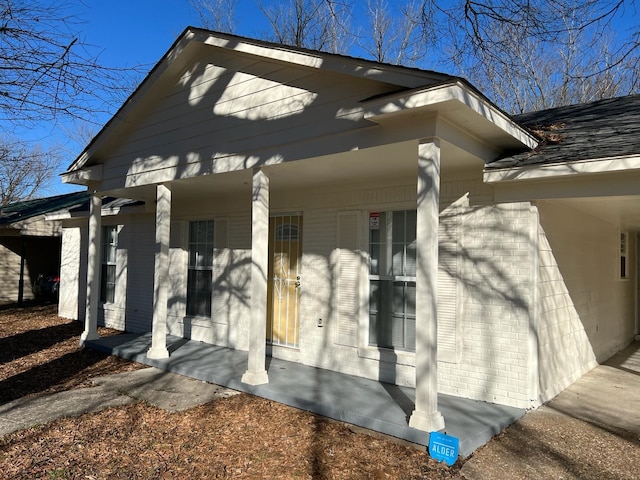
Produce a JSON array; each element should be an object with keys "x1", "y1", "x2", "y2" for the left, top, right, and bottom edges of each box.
[{"x1": 409, "y1": 139, "x2": 444, "y2": 432}]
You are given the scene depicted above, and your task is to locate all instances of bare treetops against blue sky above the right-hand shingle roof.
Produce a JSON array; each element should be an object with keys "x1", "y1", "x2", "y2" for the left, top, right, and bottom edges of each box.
[{"x1": 429, "y1": 0, "x2": 640, "y2": 113}]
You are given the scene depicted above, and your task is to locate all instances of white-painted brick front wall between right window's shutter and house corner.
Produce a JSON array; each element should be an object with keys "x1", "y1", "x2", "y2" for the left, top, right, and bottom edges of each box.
[{"x1": 438, "y1": 199, "x2": 534, "y2": 407}]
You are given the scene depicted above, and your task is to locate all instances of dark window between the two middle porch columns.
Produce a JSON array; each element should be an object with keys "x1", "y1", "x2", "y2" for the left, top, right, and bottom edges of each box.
[{"x1": 187, "y1": 220, "x2": 214, "y2": 317}]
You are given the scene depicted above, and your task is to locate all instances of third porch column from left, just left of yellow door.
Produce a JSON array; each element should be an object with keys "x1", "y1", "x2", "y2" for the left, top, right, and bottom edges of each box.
[{"x1": 242, "y1": 168, "x2": 269, "y2": 385}]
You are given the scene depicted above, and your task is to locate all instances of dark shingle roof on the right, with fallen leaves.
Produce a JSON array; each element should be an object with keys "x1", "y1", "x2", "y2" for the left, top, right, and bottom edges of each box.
[{"x1": 486, "y1": 95, "x2": 640, "y2": 170}]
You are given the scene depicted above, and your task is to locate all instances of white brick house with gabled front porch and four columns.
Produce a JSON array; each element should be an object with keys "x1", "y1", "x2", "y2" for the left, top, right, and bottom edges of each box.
[{"x1": 60, "y1": 28, "x2": 640, "y2": 431}]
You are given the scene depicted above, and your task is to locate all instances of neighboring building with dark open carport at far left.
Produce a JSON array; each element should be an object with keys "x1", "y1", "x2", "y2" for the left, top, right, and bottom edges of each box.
[{"x1": 0, "y1": 192, "x2": 89, "y2": 304}]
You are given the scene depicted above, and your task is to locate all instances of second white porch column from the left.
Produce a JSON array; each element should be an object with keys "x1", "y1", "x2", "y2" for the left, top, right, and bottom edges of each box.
[{"x1": 147, "y1": 184, "x2": 171, "y2": 358}]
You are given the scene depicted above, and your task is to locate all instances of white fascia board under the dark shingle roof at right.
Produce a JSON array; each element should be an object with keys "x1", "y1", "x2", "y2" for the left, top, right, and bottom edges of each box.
[{"x1": 483, "y1": 155, "x2": 640, "y2": 183}]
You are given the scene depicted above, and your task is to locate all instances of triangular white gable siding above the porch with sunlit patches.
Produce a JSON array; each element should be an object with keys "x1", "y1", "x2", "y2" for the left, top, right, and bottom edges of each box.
[{"x1": 103, "y1": 56, "x2": 400, "y2": 189}]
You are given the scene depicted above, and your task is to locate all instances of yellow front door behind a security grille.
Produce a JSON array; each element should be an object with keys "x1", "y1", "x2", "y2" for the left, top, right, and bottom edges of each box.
[{"x1": 267, "y1": 215, "x2": 302, "y2": 347}]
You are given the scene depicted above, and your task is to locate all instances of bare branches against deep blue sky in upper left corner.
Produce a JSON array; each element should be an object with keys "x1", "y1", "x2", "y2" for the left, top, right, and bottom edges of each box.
[{"x1": 0, "y1": 0, "x2": 131, "y2": 131}]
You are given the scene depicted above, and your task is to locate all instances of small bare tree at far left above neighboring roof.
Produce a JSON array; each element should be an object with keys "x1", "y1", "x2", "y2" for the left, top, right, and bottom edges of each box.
[{"x1": 0, "y1": 136, "x2": 61, "y2": 206}]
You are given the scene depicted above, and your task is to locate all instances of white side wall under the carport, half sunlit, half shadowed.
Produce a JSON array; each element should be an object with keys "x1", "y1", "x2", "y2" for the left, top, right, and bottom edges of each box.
[{"x1": 538, "y1": 202, "x2": 635, "y2": 401}]
